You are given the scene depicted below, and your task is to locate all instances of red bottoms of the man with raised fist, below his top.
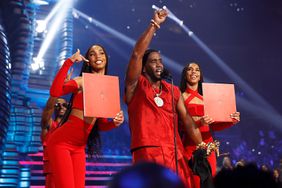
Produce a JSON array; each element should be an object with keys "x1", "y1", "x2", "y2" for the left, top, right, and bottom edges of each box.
[{"x1": 132, "y1": 147, "x2": 190, "y2": 187}]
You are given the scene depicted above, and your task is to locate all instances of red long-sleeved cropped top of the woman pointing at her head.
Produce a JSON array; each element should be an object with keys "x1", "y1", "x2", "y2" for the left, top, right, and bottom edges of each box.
[{"x1": 50, "y1": 59, "x2": 115, "y2": 131}]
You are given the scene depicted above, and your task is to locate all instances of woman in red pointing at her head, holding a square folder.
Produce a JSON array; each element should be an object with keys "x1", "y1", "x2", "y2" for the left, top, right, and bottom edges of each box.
[{"x1": 47, "y1": 45, "x2": 124, "y2": 188}]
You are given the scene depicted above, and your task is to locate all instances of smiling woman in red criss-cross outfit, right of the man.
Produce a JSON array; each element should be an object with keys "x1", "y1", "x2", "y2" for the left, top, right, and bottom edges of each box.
[{"x1": 180, "y1": 62, "x2": 240, "y2": 188}]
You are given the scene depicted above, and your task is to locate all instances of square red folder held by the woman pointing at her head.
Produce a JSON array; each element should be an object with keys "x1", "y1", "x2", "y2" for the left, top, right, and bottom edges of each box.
[{"x1": 82, "y1": 73, "x2": 120, "y2": 118}]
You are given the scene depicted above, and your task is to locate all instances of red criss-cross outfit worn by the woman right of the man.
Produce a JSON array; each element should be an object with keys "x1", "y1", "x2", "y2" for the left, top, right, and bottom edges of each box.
[{"x1": 182, "y1": 88, "x2": 233, "y2": 188}]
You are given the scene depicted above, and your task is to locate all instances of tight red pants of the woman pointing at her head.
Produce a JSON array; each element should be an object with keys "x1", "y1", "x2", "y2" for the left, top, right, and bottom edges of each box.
[{"x1": 47, "y1": 116, "x2": 92, "y2": 188}]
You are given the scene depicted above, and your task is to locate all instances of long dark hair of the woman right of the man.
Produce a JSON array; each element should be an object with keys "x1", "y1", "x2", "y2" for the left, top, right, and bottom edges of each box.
[{"x1": 179, "y1": 61, "x2": 204, "y2": 95}]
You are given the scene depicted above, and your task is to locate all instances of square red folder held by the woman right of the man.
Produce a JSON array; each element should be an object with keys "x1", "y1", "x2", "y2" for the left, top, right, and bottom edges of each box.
[{"x1": 203, "y1": 83, "x2": 236, "y2": 122}]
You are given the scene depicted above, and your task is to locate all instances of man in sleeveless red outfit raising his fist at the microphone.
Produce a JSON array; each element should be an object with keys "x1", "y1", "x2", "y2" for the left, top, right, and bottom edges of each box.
[{"x1": 125, "y1": 9, "x2": 202, "y2": 186}]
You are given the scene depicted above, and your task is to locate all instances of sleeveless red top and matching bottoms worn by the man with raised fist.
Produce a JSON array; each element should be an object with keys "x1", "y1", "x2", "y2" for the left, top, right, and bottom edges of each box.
[{"x1": 127, "y1": 75, "x2": 189, "y2": 187}]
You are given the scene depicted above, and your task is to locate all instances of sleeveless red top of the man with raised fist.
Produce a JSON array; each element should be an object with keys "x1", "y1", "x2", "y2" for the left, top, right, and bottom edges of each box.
[{"x1": 127, "y1": 75, "x2": 183, "y2": 151}]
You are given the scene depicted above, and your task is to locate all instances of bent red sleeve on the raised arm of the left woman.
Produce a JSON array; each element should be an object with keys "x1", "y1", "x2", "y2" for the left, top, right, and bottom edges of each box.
[{"x1": 50, "y1": 59, "x2": 78, "y2": 97}]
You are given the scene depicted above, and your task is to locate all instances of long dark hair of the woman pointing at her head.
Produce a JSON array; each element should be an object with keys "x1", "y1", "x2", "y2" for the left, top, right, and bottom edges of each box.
[{"x1": 60, "y1": 44, "x2": 108, "y2": 158}]
